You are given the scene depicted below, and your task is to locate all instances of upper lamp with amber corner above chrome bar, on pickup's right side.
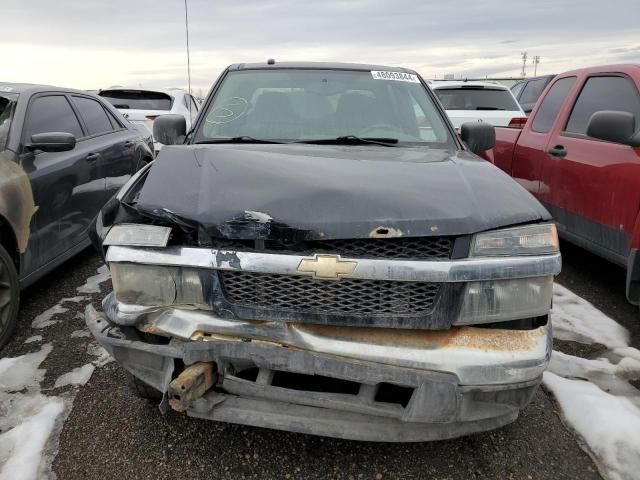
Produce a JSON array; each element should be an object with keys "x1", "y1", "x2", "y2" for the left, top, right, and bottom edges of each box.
[{"x1": 471, "y1": 223, "x2": 559, "y2": 257}]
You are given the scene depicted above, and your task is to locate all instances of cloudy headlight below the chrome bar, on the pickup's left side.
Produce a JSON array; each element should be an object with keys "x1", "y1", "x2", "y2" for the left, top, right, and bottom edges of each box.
[{"x1": 109, "y1": 262, "x2": 205, "y2": 306}]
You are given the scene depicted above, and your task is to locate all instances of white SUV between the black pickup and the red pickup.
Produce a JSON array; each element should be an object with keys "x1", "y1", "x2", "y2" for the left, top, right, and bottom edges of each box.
[{"x1": 429, "y1": 81, "x2": 527, "y2": 128}]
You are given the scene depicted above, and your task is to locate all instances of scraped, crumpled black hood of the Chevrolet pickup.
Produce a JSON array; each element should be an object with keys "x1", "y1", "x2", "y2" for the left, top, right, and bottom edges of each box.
[{"x1": 137, "y1": 144, "x2": 550, "y2": 240}]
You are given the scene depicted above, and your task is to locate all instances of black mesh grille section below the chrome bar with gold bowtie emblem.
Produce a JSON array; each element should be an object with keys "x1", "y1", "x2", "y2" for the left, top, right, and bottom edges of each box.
[{"x1": 219, "y1": 271, "x2": 441, "y2": 316}]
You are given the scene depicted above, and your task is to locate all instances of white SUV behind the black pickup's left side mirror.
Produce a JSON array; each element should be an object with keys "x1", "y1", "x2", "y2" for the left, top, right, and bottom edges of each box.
[{"x1": 98, "y1": 87, "x2": 200, "y2": 154}]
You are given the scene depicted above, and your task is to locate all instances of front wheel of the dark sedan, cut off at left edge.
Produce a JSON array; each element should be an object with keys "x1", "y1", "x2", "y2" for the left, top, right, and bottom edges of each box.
[{"x1": 0, "y1": 245, "x2": 20, "y2": 349}]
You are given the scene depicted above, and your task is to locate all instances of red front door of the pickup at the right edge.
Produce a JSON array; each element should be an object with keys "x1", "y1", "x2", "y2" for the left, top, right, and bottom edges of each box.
[{"x1": 539, "y1": 72, "x2": 640, "y2": 266}]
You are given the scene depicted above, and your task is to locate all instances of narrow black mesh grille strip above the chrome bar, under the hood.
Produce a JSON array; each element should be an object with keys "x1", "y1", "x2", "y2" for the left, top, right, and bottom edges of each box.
[{"x1": 214, "y1": 237, "x2": 454, "y2": 259}]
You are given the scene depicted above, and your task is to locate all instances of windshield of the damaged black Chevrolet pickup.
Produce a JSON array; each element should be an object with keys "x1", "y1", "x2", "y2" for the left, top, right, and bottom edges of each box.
[{"x1": 194, "y1": 69, "x2": 456, "y2": 148}]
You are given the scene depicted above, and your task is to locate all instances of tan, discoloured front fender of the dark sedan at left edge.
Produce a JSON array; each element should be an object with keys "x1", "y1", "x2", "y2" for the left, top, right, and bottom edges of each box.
[{"x1": 0, "y1": 153, "x2": 38, "y2": 253}]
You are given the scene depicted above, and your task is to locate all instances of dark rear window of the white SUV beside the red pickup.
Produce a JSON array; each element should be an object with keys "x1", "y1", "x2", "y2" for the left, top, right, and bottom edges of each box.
[{"x1": 434, "y1": 87, "x2": 520, "y2": 111}]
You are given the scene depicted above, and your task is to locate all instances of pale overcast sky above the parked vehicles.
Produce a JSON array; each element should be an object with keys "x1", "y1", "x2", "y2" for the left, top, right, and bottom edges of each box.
[{"x1": 0, "y1": 0, "x2": 640, "y2": 92}]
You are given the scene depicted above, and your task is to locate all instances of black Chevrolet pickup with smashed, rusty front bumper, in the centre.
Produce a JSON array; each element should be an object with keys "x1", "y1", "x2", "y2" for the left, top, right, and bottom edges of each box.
[{"x1": 86, "y1": 61, "x2": 561, "y2": 441}]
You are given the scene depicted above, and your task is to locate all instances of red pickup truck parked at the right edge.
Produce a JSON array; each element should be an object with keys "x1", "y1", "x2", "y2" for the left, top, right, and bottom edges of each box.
[{"x1": 485, "y1": 65, "x2": 640, "y2": 304}]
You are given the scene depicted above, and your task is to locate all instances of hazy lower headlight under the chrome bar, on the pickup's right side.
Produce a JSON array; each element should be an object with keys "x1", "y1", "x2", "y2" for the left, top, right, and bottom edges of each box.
[{"x1": 454, "y1": 275, "x2": 553, "y2": 325}]
